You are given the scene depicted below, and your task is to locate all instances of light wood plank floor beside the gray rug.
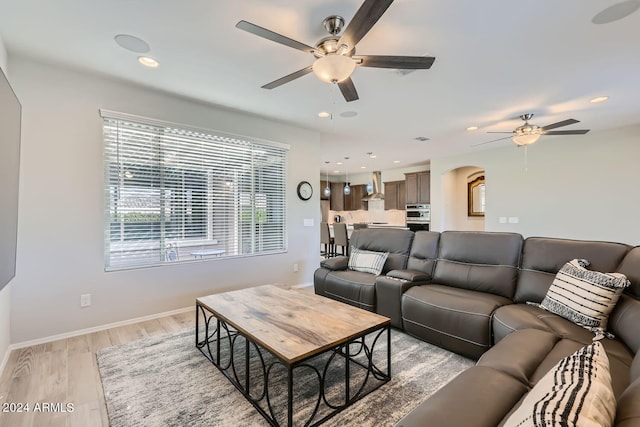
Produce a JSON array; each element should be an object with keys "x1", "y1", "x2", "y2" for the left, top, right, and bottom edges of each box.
[{"x1": 0, "y1": 287, "x2": 313, "y2": 427}]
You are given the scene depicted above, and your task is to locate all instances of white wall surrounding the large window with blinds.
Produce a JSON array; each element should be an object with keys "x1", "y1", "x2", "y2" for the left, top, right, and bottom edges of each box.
[{"x1": 11, "y1": 57, "x2": 320, "y2": 343}]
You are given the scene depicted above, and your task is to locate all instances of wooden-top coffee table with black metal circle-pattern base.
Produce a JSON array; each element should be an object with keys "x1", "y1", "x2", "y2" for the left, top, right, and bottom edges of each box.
[{"x1": 196, "y1": 285, "x2": 391, "y2": 426}]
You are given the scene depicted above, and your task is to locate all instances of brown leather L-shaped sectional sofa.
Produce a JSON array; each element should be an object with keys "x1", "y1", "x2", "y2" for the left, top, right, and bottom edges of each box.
[{"x1": 314, "y1": 229, "x2": 640, "y2": 427}]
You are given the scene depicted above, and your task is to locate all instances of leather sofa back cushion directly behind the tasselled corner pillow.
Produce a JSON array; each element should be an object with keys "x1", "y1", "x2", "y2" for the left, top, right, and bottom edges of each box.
[{"x1": 514, "y1": 237, "x2": 630, "y2": 304}]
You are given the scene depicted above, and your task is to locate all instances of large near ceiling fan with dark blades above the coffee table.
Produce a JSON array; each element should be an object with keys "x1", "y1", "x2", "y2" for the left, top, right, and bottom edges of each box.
[{"x1": 236, "y1": 0, "x2": 435, "y2": 102}]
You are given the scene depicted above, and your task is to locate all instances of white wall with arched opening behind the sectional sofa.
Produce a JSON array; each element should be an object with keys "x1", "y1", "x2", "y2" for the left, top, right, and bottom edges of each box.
[{"x1": 431, "y1": 125, "x2": 640, "y2": 245}]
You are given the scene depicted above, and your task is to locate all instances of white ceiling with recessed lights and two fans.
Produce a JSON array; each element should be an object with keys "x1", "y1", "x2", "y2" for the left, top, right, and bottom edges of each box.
[{"x1": 0, "y1": 0, "x2": 640, "y2": 175}]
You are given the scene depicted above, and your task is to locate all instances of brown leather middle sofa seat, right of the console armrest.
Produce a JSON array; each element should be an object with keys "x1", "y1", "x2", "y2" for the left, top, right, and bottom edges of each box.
[{"x1": 402, "y1": 284, "x2": 511, "y2": 359}]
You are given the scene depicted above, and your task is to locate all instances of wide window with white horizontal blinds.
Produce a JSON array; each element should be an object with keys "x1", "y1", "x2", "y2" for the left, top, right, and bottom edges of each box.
[{"x1": 101, "y1": 110, "x2": 288, "y2": 270}]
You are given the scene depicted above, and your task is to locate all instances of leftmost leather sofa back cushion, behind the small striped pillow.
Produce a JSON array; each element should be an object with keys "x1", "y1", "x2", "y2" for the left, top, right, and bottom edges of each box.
[{"x1": 349, "y1": 228, "x2": 414, "y2": 274}]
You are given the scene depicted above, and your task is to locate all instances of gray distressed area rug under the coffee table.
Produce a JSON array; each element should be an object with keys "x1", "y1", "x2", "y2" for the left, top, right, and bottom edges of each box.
[{"x1": 97, "y1": 329, "x2": 474, "y2": 427}]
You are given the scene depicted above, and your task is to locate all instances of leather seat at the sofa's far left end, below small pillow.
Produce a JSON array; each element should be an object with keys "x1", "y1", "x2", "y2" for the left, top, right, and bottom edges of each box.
[{"x1": 324, "y1": 270, "x2": 377, "y2": 311}]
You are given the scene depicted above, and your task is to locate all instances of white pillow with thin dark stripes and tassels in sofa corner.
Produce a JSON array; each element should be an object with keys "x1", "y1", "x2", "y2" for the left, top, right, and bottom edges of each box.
[{"x1": 540, "y1": 259, "x2": 631, "y2": 333}]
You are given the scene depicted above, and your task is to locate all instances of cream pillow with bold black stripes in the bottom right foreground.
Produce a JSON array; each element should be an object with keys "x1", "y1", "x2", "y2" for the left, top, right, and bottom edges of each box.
[{"x1": 504, "y1": 341, "x2": 616, "y2": 427}]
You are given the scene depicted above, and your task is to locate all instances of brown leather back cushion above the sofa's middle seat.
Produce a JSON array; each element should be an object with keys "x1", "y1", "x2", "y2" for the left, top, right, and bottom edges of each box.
[{"x1": 432, "y1": 231, "x2": 522, "y2": 298}]
